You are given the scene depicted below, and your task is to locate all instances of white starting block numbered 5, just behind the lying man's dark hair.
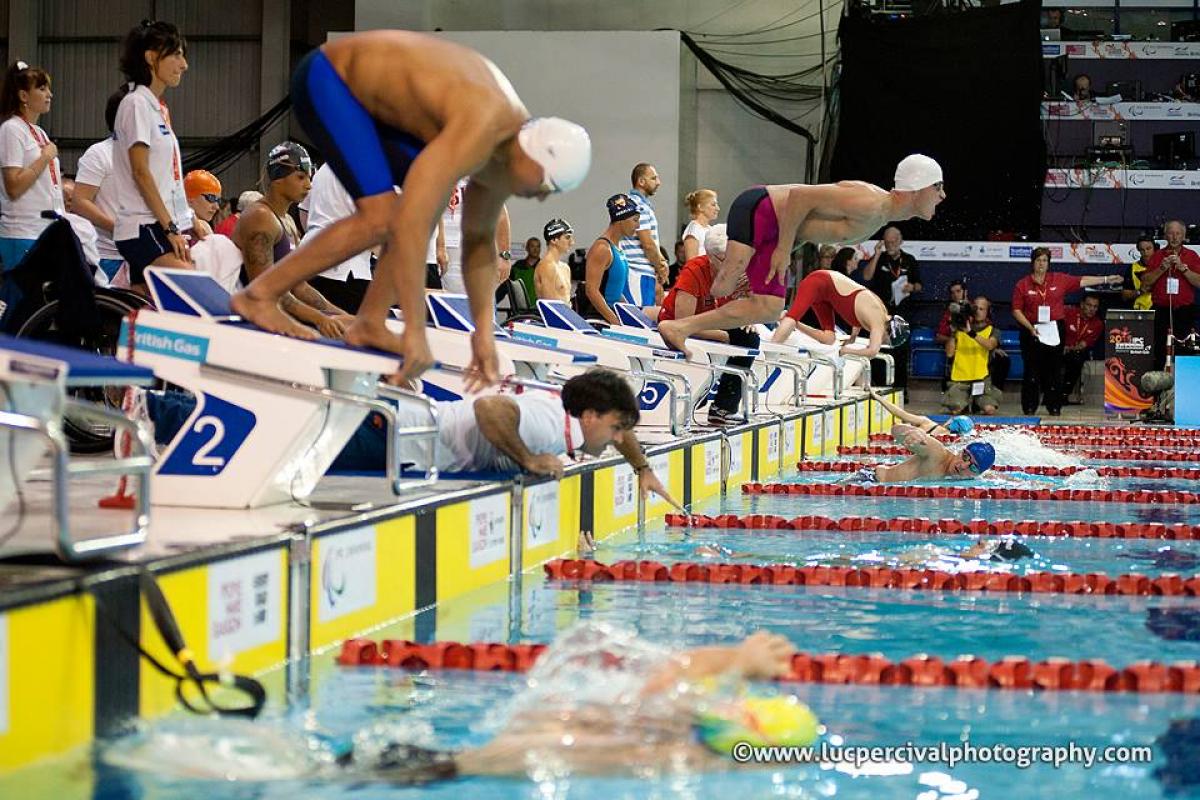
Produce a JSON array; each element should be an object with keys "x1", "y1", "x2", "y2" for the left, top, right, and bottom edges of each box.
[{"x1": 512, "y1": 300, "x2": 696, "y2": 435}]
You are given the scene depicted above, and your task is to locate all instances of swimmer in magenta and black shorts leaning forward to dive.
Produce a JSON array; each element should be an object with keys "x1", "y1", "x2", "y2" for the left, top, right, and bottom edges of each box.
[{"x1": 659, "y1": 155, "x2": 946, "y2": 355}]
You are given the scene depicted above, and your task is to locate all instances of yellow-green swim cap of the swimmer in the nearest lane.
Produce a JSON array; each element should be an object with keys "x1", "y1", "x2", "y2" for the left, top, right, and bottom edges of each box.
[{"x1": 696, "y1": 694, "x2": 821, "y2": 756}]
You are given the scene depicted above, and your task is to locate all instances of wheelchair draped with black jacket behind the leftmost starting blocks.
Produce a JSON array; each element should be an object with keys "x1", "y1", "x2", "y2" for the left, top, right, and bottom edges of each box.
[{"x1": 0, "y1": 218, "x2": 150, "y2": 453}]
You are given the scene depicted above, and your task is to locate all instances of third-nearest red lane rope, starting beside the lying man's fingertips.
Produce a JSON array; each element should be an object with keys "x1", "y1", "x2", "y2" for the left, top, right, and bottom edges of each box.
[{"x1": 666, "y1": 513, "x2": 1200, "y2": 541}]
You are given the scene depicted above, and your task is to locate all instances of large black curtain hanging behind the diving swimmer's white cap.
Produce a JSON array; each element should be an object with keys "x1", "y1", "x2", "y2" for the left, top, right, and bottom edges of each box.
[{"x1": 830, "y1": 0, "x2": 1046, "y2": 240}]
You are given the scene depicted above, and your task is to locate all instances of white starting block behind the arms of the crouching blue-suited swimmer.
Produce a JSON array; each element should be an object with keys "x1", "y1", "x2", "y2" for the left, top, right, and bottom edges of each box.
[{"x1": 388, "y1": 293, "x2": 596, "y2": 401}]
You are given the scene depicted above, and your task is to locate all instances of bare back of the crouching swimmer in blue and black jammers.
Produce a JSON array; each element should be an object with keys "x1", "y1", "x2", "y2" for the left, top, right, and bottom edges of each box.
[{"x1": 323, "y1": 30, "x2": 529, "y2": 144}]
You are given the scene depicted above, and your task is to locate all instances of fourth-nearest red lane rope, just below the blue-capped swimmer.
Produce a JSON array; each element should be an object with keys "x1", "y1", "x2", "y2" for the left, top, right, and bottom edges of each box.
[{"x1": 742, "y1": 483, "x2": 1200, "y2": 505}]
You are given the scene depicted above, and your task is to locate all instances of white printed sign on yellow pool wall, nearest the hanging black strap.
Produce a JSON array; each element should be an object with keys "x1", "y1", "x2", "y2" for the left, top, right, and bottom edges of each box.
[{"x1": 209, "y1": 551, "x2": 283, "y2": 663}]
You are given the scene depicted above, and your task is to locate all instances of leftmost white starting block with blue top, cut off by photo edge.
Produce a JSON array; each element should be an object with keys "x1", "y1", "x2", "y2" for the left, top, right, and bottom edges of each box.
[{"x1": 0, "y1": 336, "x2": 154, "y2": 561}]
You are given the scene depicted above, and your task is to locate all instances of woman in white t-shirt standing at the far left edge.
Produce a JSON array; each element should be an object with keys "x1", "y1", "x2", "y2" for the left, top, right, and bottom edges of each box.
[{"x1": 0, "y1": 61, "x2": 65, "y2": 272}]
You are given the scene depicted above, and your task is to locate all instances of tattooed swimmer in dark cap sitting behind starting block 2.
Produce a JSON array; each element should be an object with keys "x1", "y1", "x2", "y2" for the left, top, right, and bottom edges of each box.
[{"x1": 233, "y1": 142, "x2": 354, "y2": 338}]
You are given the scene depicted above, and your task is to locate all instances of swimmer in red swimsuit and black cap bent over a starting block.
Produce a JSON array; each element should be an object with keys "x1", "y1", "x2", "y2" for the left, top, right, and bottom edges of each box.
[{"x1": 770, "y1": 270, "x2": 908, "y2": 359}]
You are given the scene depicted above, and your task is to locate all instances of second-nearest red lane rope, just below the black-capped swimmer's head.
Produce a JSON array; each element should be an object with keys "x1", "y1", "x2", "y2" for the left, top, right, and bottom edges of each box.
[{"x1": 544, "y1": 559, "x2": 1200, "y2": 597}]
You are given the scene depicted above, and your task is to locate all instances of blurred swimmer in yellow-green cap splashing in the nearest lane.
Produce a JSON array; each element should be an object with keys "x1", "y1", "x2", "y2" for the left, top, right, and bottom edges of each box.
[{"x1": 106, "y1": 621, "x2": 820, "y2": 786}]
